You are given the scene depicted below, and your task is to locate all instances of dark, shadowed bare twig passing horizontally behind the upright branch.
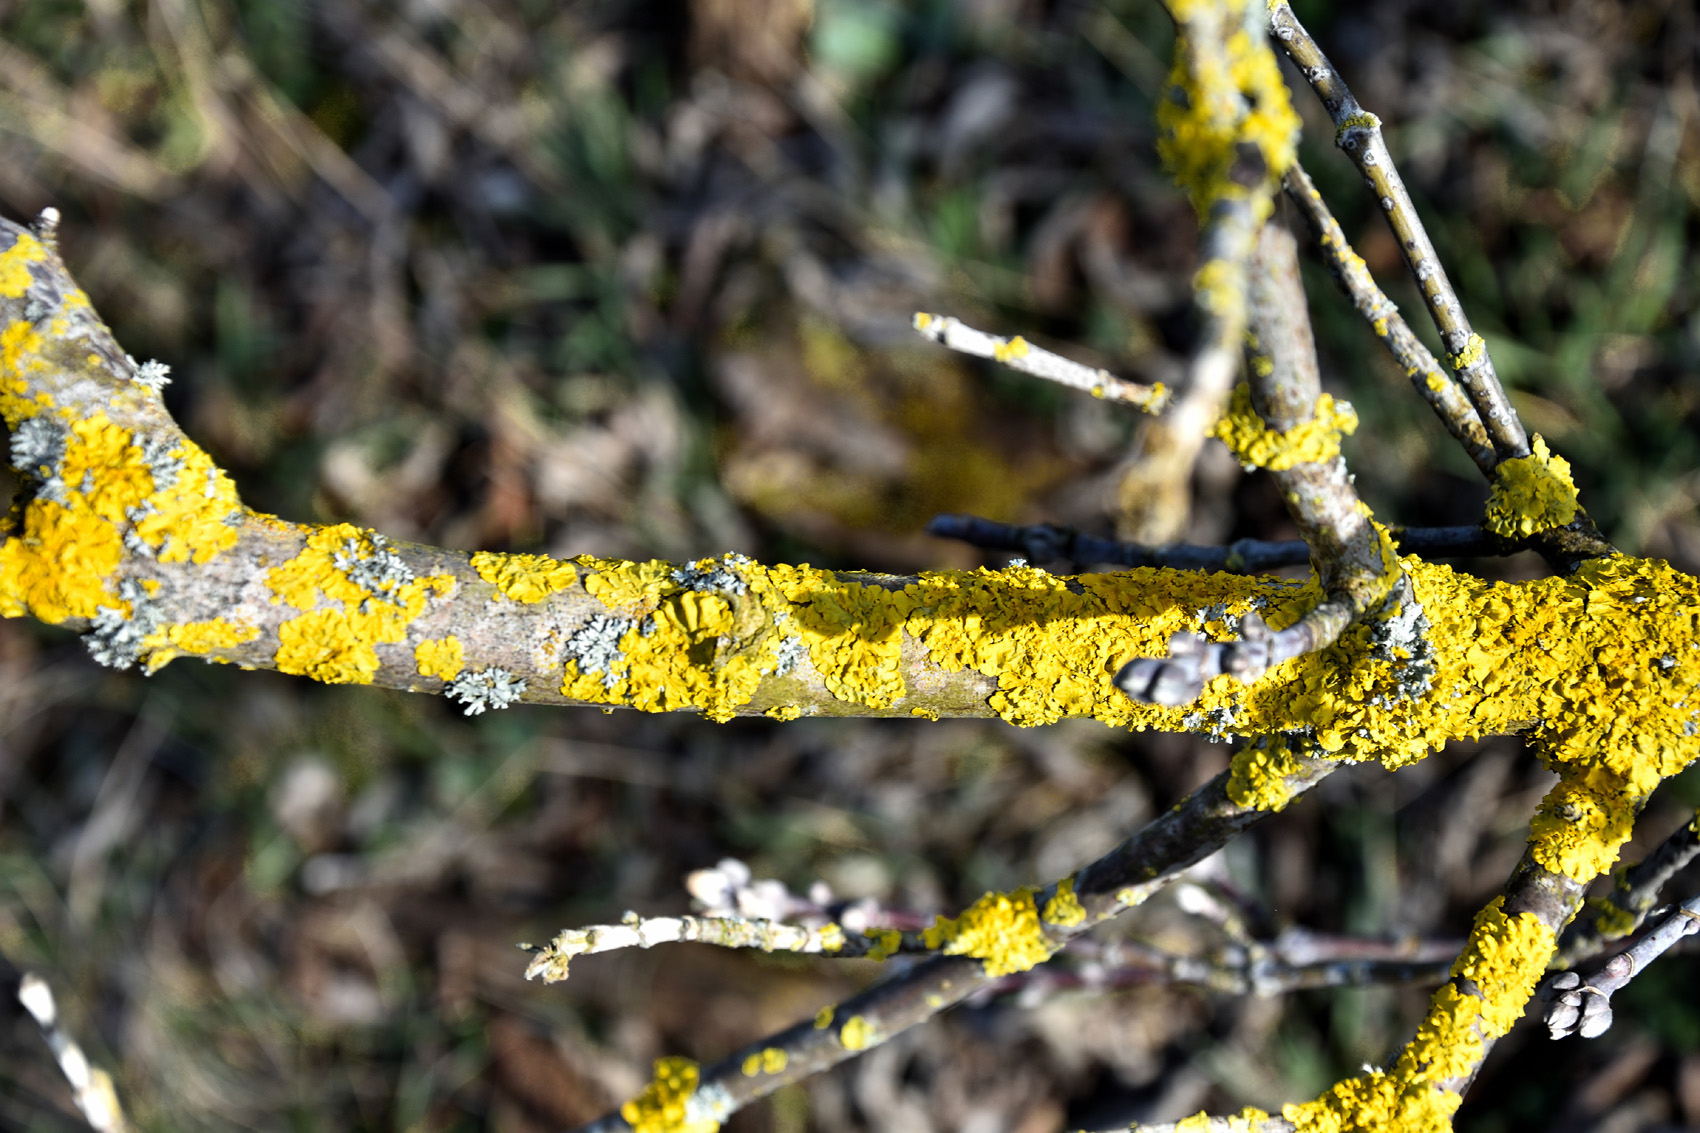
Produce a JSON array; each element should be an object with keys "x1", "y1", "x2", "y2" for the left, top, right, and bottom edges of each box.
[{"x1": 927, "y1": 515, "x2": 1530, "y2": 575}]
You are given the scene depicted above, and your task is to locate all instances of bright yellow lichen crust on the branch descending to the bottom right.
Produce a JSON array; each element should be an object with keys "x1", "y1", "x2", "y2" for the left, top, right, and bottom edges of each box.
[{"x1": 1282, "y1": 898, "x2": 1557, "y2": 1133}]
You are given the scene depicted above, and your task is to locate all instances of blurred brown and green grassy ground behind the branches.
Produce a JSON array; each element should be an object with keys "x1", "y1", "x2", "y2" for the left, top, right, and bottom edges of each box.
[{"x1": 0, "y1": 0, "x2": 1700, "y2": 1133}]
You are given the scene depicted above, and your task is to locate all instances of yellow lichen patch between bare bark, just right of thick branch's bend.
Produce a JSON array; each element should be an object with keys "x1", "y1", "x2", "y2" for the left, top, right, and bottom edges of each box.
[{"x1": 265, "y1": 524, "x2": 454, "y2": 684}]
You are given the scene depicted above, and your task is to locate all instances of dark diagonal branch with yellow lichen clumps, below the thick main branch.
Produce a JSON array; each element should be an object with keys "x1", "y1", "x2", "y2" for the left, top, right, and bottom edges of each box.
[{"x1": 557, "y1": 745, "x2": 1338, "y2": 1133}]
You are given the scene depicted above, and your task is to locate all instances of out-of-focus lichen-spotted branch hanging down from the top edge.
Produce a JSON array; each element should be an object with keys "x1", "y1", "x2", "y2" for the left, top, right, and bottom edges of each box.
[{"x1": 1120, "y1": 0, "x2": 1299, "y2": 543}]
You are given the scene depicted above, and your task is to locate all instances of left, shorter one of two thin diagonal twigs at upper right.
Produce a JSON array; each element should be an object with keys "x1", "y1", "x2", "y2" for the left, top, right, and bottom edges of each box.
[{"x1": 1287, "y1": 162, "x2": 1498, "y2": 480}]
